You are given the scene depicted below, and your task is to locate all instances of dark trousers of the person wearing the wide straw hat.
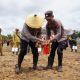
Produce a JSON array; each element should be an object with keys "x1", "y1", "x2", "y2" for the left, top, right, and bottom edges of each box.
[{"x1": 18, "y1": 39, "x2": 39, "y2": 67}]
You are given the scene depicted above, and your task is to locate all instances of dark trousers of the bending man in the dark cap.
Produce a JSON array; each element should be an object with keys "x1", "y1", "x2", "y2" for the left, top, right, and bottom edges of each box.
[{"x1": 48, "y1": 41, "x2": 65, "y2": 67}]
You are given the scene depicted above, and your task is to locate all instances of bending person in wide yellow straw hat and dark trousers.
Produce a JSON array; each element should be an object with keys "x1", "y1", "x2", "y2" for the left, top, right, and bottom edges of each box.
[{"x1": 16, "y1": 15, "x2": 44, "y2": 73}]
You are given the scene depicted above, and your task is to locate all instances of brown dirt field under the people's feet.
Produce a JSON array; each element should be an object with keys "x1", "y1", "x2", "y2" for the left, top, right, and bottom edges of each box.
[{"x1": 0, "y1": 46, "x2": 80, "y2": 80}]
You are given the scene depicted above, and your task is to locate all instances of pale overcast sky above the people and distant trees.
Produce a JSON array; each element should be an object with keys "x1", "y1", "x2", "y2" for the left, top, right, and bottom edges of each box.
[{"x1": 0, "y1": 0, "x2": 80, "y2": 34}]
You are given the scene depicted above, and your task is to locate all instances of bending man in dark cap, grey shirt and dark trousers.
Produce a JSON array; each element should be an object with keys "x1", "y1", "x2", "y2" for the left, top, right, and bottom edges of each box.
[{"x1": 45, "y1": 11, "x2": 66, "y2": 72}]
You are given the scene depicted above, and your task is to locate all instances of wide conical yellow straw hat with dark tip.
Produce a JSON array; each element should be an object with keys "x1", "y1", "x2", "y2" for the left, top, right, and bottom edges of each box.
[{"x1": 25, "y1": 14, "x2": 44, "y2": 28}]
